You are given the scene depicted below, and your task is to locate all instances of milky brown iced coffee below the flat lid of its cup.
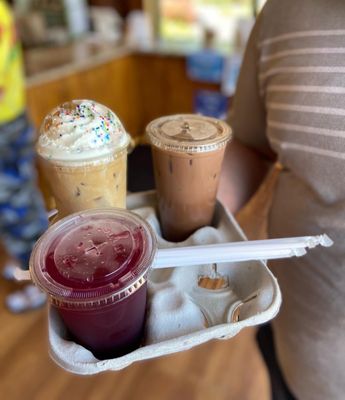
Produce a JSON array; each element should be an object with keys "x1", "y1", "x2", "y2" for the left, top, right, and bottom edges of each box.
[{"x1": 152, "y1": 146, "x2": 225, "y2": 242}]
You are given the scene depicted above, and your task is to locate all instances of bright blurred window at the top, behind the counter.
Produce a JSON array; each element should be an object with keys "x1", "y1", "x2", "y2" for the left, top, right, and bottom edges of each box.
[{"x1": 146, "y1": 0, "x2": 263, "y2": 53}]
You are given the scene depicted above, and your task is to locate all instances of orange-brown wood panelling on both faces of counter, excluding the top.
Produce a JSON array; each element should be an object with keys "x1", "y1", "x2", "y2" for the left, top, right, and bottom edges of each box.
[{"x1": 27, "y1": 50, "x2": 218, "y2": 136}]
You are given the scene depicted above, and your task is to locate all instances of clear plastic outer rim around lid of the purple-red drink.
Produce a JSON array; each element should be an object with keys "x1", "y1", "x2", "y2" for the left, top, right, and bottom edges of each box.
[{"x1": 29, "y1": 208, "x2": 157, "y2": 309}]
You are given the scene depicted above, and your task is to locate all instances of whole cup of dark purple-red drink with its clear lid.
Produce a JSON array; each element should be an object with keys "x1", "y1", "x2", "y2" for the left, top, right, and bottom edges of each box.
[{"x1": 30, "y1": 209, "x2": 156, "y2": 359}]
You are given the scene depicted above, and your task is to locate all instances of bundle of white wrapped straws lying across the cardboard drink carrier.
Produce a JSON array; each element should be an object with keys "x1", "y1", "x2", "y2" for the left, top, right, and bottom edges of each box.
[{"x1": 153, "y1": 235, "x2": 333, "y2": 268}]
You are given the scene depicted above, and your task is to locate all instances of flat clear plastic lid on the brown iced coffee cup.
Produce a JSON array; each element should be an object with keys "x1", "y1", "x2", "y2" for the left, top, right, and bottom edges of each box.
[{"x1": 146, "y1": 114, "x2": 231, "y2": 153}]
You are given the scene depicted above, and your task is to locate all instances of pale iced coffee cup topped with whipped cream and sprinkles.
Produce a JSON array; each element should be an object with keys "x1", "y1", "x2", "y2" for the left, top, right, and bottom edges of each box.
[{"x1": 37, "y1": 100, "x2": 129, "y2": 218}]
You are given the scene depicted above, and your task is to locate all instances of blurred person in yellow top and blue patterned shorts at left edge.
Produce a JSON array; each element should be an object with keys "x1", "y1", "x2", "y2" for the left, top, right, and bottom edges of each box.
[{"x1": 0, "y1": 0, "x2": 47, "y2": 312}]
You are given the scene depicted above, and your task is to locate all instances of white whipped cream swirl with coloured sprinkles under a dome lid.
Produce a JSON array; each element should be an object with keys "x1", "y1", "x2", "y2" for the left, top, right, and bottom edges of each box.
[{"x1": 37, "y1": 100, "x2": 129, "y2": 161}]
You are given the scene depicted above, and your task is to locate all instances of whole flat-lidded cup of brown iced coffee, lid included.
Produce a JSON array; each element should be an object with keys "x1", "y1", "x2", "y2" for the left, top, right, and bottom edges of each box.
[{"x1": 147, "y1": 114, "x2": 231, "y2": 241}]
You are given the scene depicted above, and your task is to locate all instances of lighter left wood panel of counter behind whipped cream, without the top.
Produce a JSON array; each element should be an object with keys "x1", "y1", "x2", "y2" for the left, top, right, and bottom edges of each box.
[{"x1": 27, "y1": 56, "x2": 140, "y2": 134}]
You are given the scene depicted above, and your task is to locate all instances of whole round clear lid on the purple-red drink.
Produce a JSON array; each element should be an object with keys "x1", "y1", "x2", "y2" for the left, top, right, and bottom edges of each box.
[{"x1": 30, "y1": 209, "x2": 156, "y2": 307}]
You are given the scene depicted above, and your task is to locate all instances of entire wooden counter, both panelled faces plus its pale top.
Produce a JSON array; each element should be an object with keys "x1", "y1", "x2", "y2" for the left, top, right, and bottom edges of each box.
[{"x1": 27, "y1": 40, "x2": 218, "y2": 136}]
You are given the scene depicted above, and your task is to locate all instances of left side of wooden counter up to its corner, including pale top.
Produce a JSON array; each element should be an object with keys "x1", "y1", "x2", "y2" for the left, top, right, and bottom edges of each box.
[{"x1": 27, "y1": 42, "x2": 139, "y2": 134}]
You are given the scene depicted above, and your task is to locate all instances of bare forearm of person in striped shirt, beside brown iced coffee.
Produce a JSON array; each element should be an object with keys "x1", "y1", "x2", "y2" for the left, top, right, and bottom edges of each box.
[{"x1": 218, "y1": 139, "x2": 273, "y2": 213}]
